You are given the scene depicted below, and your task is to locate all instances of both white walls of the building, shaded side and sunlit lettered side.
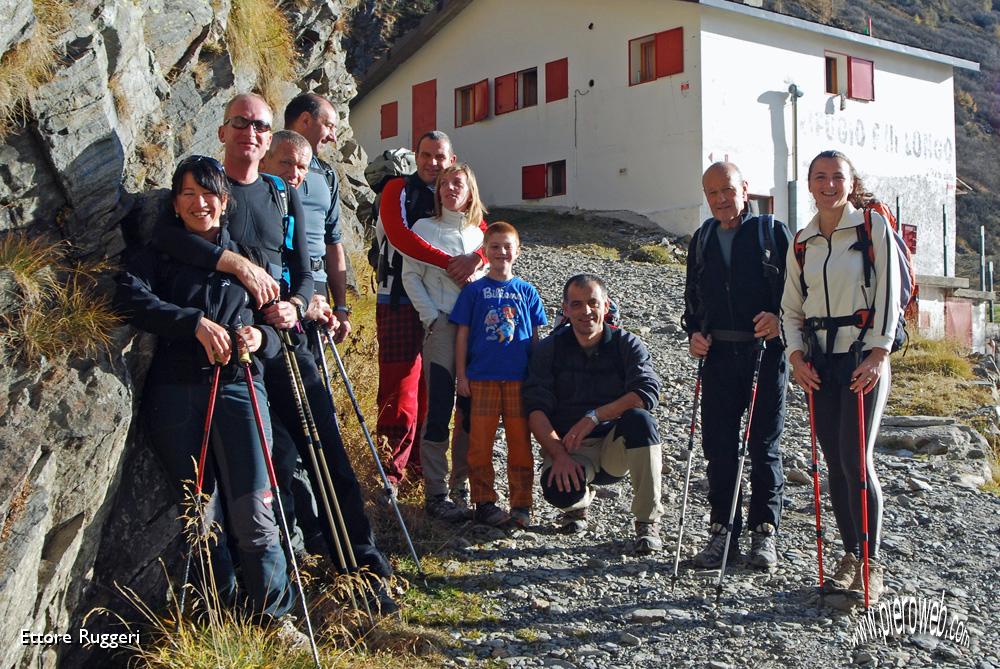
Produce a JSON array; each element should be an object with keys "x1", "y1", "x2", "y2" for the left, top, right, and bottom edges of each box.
[{"x1": 351, "y1": 0, "x2": 955, "y2": 248}]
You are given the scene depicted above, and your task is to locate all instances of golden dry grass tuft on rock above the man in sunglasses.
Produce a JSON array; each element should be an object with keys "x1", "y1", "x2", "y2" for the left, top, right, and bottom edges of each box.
[{"x1": 226, "y1": 0, "x2": 297, "y2": 109}]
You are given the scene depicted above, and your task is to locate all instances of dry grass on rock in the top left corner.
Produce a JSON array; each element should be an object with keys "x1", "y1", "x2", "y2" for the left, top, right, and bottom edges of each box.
[{"x1": 0, "y1": 0, "x2": 70, "y2": 140}]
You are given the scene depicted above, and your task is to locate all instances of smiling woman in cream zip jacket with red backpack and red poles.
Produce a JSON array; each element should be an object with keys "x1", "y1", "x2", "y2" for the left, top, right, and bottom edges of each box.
[{"x1": 781, "y1": 151, "x2": 900, "y2": 603}]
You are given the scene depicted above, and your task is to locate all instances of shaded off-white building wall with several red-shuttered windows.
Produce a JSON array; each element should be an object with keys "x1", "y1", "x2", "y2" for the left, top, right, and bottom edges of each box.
[{"x1": 351, "y1": 0, "x2": 701, "y2": 229}]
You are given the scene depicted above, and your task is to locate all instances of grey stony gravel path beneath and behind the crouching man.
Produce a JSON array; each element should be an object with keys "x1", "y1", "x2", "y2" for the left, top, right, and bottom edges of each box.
[{"x1": 438, "y1": 217, "x2": 1000, "y2": 669}]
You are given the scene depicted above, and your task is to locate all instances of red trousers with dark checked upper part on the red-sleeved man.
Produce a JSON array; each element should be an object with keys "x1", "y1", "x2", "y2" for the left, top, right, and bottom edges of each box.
[{"x1": 375, "y1": 304, "x2": 427, "y2": 485}]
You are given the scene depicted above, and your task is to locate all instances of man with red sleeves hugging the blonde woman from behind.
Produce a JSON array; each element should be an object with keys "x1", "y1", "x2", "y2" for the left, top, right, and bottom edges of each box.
[{"x1": 375, "y1": 130, "x2": 485, "y2": 520}]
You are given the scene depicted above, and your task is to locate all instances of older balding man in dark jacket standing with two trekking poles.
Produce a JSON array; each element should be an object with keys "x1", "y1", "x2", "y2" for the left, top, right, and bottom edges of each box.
[{"x1": 682, "y1": 163, "x2": 789, "y2": 568}]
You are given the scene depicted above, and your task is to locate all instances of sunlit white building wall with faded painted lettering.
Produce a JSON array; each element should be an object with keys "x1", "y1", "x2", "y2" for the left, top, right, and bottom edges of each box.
[{"x1": 701, "y1": 8, "x2": 955, "y2": 275}]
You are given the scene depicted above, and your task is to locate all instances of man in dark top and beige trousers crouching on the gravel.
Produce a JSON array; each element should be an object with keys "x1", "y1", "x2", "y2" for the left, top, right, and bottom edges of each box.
[{"x1": 523, "y1": 274, "x2": 663, "y2": 554}]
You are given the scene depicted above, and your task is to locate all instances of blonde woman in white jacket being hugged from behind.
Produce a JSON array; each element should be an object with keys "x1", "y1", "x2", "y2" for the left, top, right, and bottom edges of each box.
[{"x1": 402, "y1": 163, "x2": 486, "y2": 520}]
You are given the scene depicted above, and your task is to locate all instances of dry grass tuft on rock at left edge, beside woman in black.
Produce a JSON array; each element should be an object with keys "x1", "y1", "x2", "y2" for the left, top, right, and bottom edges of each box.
[{"x1": 0, "y1": 233, "x2": 120, "y2": 364}]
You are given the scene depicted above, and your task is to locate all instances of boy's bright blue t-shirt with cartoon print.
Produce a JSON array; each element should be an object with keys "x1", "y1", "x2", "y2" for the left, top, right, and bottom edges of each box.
[{"x1": 450, "y1": 276, "x2": 547, "y2": 381}]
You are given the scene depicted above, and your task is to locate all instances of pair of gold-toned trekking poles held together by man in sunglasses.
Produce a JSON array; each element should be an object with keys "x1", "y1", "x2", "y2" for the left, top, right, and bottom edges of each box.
[{"x1": 279, "y1": 330, "x2": 374, "y2": 620}]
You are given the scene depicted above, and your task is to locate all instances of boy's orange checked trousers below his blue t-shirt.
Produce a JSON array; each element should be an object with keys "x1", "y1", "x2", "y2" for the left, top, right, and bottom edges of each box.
[{"x1": 469, "y1": 381, "x2": 535, "y2": 508}]
